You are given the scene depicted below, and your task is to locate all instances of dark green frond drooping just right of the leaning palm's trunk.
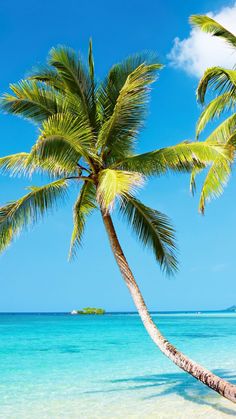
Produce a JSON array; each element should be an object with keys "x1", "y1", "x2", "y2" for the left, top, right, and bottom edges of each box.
[{"x1": 120, "y1": 195, "x2": 177, "y2": 274}]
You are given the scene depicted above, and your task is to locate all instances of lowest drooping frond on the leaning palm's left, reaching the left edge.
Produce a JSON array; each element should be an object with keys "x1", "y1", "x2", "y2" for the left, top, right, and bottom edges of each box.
[{"x1": 0, "y1": 179, "x2": 68, "y2": 251}]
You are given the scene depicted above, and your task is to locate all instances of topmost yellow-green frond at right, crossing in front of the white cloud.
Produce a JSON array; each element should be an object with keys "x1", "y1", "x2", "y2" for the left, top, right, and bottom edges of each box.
[{"x1": 190, "y1": 15, "x2": 236, "y2": 47}]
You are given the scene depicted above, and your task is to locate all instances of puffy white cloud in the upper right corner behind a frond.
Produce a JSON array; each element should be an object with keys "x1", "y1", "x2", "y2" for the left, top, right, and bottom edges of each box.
[{"x1": 168, "y1": 2, "x2": 236, "y2": 77}]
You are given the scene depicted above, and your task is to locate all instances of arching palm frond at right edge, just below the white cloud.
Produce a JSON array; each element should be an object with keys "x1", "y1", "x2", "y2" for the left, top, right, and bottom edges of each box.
[{"x1": 197, "y1": 67, "x2": 236, "y2": 104}]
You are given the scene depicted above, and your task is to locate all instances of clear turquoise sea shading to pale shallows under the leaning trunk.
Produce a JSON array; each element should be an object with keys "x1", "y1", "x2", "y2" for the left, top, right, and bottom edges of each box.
[{"x1": 0, "y1": 314, "x2": 236, "y2": 419}]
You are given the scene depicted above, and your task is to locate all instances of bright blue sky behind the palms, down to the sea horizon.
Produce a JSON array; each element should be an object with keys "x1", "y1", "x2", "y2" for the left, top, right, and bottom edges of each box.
[{"x1": 0, "y1": 0, "x2": 236, "y2": 311}]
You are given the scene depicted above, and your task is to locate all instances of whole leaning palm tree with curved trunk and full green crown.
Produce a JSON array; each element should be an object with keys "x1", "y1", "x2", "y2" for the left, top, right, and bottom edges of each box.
[{"x1": 0, "y1": 42, "x2": 236, "y2": 402}]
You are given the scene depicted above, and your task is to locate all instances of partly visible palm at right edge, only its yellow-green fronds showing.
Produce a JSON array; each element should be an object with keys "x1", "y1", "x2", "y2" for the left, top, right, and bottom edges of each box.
[{"x1": 190, "y1": 15, "x2": 236, "y2": 213}]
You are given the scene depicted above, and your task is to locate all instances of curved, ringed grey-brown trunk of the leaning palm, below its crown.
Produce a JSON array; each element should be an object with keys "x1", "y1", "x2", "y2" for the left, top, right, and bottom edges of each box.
[{"x1": 101, "y1": 210, "x2": 236, "y2": 403}]
